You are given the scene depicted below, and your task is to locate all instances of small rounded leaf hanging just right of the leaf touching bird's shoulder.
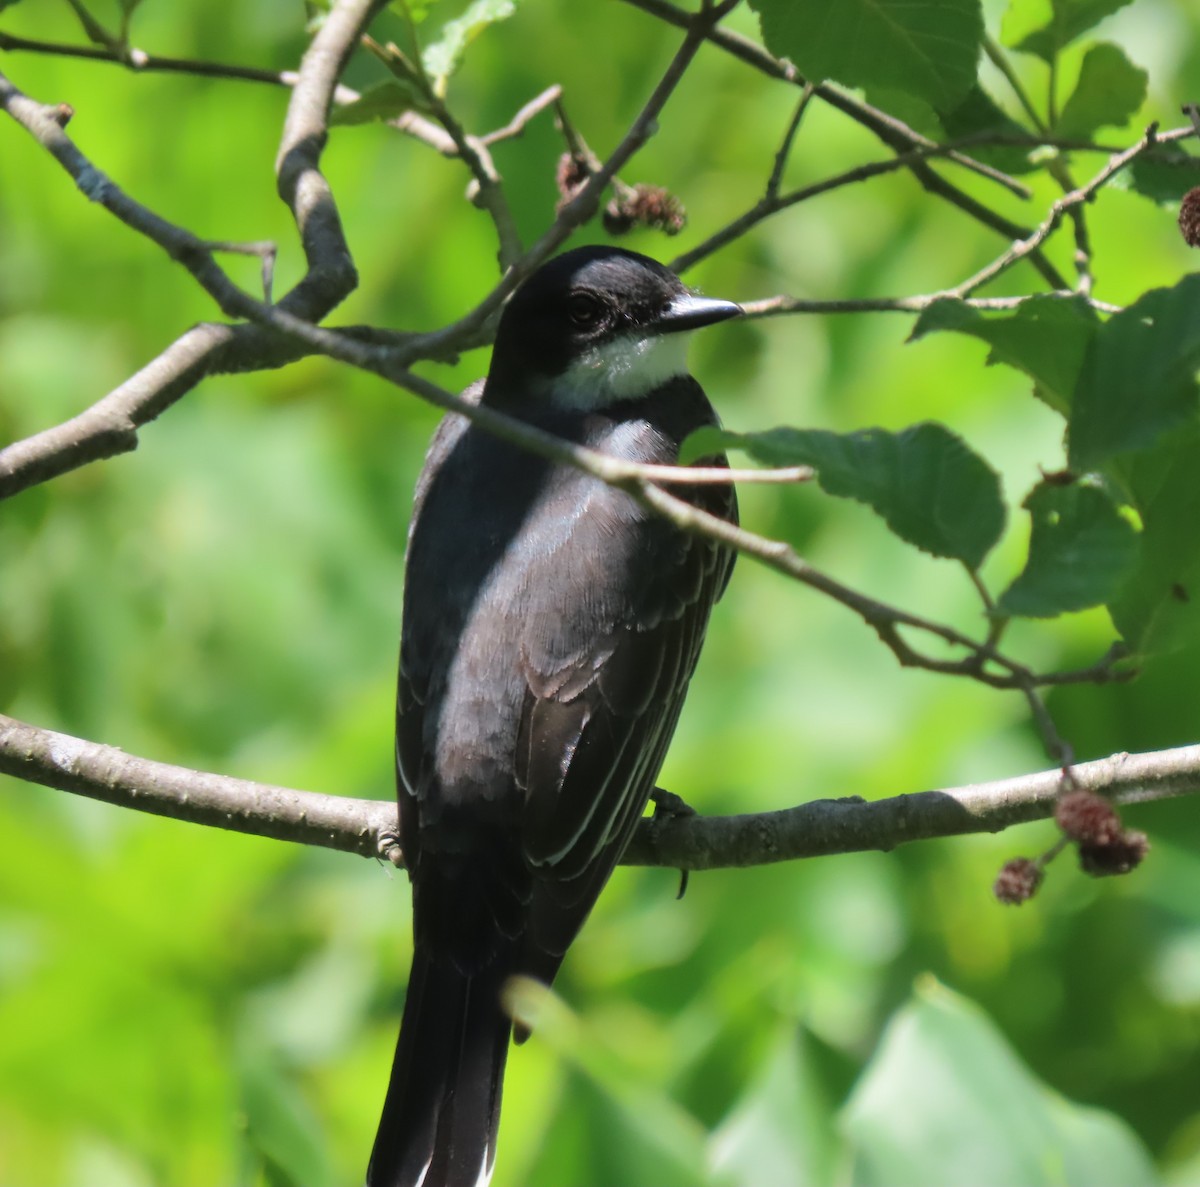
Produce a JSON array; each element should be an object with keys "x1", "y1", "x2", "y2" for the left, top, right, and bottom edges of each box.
[{"x1": 997, "y1": 482, "x2": 1138, "y2": 618}]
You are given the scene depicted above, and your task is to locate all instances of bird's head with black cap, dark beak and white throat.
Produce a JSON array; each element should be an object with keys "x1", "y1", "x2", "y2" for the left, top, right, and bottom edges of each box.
[{"x1": 484, "y1": 247, "x2": 742, "y2": 412}]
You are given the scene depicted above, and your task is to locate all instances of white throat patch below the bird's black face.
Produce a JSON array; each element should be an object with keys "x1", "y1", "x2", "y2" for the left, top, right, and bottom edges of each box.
[{"x1": 546, "y1": 331, "x2": 691, "y2": 412}]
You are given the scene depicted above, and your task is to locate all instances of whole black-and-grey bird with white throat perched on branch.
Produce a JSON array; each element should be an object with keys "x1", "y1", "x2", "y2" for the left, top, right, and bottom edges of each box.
[{"x1": 367, "y1": 246, "x2": 743, "y2": 1187}]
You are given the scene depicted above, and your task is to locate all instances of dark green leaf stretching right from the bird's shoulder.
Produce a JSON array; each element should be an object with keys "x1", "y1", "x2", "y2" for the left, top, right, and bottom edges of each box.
[{"x1": 684, "y1": 421, "x2": 1004, "y2": 569}]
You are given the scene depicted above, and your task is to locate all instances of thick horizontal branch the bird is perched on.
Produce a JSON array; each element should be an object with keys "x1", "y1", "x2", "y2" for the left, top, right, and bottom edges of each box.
[{"x1": 0, "y1": 715, "x2": 1200, "y2": 870}]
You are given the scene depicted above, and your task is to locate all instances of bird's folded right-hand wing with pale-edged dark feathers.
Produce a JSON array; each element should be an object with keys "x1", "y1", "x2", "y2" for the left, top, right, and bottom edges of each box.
[{"x1": 515, "y1": 385, "x2": 737, "y2": 982}]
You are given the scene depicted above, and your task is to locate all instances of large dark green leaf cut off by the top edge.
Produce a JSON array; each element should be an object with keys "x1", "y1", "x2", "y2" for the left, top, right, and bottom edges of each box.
[{"x1": 751, "y1": 0, "x2": 983, "y2": 108}]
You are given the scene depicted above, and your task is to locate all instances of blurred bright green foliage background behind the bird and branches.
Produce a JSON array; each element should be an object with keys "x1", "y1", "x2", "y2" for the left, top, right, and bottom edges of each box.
[{"x1": 0, "y1": 0, "x2": 1200, "y2": 1187}]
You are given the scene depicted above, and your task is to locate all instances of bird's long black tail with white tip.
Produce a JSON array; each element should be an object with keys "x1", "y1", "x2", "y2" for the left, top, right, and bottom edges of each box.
[{"x1": 367, "y1": 948, "x2": 512, "y2": 1187}]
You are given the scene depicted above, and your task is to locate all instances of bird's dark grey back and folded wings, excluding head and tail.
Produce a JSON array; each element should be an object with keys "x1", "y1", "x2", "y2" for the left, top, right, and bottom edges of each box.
[{"x1": 396, "y1": 379, "x2": 737, "y2": 982}]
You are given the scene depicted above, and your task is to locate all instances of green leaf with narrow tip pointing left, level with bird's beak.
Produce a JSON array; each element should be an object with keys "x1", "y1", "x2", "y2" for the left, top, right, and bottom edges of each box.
[{"x1": 908, "y1": 295, "x2": 1099, "y2": 415}]
